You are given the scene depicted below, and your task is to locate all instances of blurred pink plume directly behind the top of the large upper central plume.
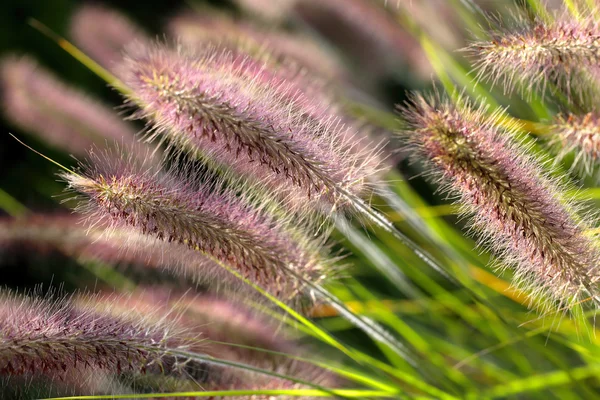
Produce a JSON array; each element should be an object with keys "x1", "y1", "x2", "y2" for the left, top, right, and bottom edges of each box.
[{"x1": 169, "y1": 9, "x2": 389, "y2": 182}]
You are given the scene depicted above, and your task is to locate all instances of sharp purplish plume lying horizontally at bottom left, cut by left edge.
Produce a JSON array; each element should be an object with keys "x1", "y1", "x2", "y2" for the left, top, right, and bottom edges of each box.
[{"x1": 0, "y1": 292, "x2": 192, "y2": 376}]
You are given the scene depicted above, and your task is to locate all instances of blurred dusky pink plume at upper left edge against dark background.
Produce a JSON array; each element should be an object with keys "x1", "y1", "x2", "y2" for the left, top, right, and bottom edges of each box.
[{"x1": 0, "y1": 56, "x2": 144, "y2": 156}]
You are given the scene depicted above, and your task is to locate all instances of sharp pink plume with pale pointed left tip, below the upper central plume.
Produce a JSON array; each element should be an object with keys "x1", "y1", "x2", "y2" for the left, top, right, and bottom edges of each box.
[{"x1": 63, "y1": 152, "x2": 328, "y2": 298}]
